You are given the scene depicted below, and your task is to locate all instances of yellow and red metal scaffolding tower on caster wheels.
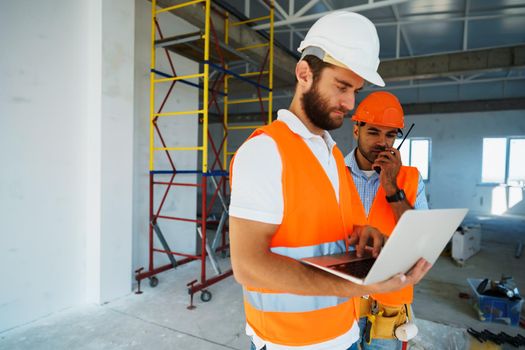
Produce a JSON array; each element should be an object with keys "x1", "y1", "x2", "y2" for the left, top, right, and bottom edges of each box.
[{"x1": 135, "y1": 0, "x2": 274, "y2": 307}]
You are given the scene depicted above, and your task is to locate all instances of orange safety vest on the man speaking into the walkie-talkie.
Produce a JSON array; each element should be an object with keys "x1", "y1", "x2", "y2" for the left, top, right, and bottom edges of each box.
[{"x1": 347, "y1": 166, "x2": 419, "y2": 306}]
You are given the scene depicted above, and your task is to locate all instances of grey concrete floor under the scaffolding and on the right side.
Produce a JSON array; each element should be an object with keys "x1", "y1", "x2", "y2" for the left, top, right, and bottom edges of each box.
[{"x1": 0, "y1": 217, "x2": 525, "y2": 350}]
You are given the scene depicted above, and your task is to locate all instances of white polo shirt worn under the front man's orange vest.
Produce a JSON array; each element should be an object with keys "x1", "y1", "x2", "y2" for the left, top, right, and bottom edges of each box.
[{"x1": 229, "y1": 109, "x2": 359, "y2": 350}]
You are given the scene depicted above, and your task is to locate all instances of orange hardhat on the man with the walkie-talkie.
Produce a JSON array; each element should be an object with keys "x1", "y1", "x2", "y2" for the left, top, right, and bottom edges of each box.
[{"x1": 352, "y1": 91, "x2": 405, "y2": 129}]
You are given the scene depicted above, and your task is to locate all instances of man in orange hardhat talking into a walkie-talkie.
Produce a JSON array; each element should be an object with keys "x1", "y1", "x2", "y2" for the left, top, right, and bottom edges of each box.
[{"x1": 345, "y1": 91, "x2": 428, "y2": 349}]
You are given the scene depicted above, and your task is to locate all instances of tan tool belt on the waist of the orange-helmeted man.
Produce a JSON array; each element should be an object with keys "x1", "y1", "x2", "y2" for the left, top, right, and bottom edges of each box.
[{"x1": 359, "y1": 297, "x2": 408, "y2": 343}]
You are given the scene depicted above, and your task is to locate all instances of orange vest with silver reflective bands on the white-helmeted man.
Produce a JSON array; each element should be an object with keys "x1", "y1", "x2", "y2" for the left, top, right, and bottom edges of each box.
[{"x1": 230, "y1": 121, "x2": 359, "y2": 346}]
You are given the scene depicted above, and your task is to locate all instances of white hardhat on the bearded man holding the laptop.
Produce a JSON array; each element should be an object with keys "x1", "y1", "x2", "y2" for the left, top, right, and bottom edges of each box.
[{"x1": 297, "y1": 11, "x2": 385, "y2": 86}]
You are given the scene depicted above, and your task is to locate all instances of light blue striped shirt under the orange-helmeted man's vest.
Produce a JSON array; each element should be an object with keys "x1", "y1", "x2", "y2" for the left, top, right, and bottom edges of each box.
[{"x1": 345, "y1": 149, "x2": 428, "y2": 215}]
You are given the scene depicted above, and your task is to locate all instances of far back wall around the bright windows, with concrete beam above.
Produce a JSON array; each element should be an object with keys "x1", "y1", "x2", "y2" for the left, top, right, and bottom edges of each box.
[{"x1": 407, "y1": 110, "x2": 525, "y2": 215}]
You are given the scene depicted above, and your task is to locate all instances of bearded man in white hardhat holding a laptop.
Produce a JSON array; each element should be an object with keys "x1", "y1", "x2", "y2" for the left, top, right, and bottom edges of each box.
[{"x1": 229, "y1": 11, "x2": 430, "y2": 350}]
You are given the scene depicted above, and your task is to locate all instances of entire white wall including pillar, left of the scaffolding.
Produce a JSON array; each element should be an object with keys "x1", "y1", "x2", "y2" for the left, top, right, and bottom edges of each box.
[{"x1": 0, "y1": 0, "x2": 134, "y2": 332}]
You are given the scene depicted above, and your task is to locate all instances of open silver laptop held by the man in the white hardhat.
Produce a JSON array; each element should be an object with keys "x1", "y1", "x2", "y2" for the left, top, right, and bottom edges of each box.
[{"x1": 301, "y1": 209, "x2": 468, "y2": 284}]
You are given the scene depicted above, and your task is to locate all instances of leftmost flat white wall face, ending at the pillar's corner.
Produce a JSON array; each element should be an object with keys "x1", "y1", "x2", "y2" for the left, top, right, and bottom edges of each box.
[{"x1": 0, "y1": 0, "x2": 89, "y2": 331}]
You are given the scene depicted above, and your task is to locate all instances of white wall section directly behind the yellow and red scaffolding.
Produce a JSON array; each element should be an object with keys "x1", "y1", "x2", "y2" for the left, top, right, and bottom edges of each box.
[{"x1": 133, "y1": 0, "x2": 200, "y2": 272}]
